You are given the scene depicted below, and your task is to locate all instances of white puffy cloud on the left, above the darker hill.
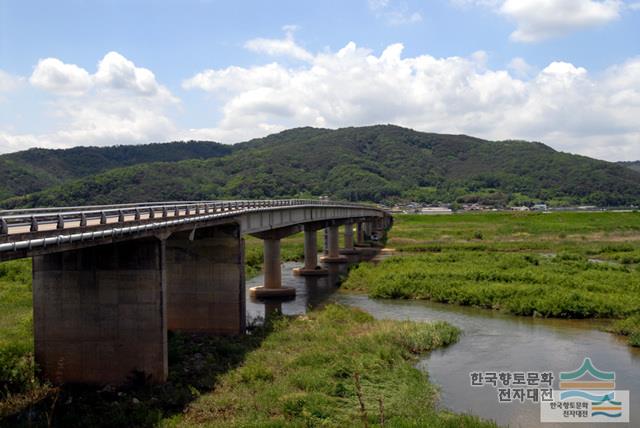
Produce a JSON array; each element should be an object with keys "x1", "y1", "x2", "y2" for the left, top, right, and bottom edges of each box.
[{"x1": 0, "y1": 52, "x2": 179, "y2": 152}]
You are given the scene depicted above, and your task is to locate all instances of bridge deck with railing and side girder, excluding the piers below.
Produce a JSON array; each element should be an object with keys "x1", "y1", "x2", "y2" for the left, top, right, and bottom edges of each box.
[{"x1": 0, "y1": 199, "x2": 385, "y2": 261}]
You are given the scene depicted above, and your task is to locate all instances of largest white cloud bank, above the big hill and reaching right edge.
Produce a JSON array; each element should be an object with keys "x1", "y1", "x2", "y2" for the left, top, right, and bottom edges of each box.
[{"x1": 183, "y1": 42, "x2": 640, "y2": 159}]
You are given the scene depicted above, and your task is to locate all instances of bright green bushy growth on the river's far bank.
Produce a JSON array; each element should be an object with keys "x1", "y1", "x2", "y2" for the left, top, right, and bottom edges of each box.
[{"x1": 343, "y1": 250, "x2": 640, "y2": 318}]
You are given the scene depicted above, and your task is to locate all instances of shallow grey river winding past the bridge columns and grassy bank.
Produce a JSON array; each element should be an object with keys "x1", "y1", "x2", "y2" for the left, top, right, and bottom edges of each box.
[{"x1": 247, "y1": 259, "x2": 640, "y2": 427}]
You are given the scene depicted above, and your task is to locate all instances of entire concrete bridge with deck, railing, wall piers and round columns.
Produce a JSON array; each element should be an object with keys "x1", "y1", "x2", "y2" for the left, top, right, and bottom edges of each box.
[{"x1": 0, "y1": 200, "x2": 391, "y2": 384}]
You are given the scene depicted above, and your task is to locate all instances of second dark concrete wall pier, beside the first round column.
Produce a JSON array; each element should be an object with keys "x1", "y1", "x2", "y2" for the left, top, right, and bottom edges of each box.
[{"x1": 165, "y1": 225, "x2": 246, "y2": 335}]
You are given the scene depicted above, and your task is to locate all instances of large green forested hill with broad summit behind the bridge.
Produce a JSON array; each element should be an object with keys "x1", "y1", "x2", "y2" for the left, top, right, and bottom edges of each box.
[{"x1": 0, "y1": 125, "x2": 640, "y2": 207}]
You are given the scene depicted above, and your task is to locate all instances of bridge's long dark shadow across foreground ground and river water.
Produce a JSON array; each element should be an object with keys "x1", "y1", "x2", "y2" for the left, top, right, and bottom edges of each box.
[{"x1": 5, "y1": 249, "x2": 378, "y2": 427}]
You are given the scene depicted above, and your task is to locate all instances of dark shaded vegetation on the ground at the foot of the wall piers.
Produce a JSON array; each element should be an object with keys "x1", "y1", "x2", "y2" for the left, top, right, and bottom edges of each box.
[{"x1": 0, "y1": 316, "x2": 270, "y2": 427}]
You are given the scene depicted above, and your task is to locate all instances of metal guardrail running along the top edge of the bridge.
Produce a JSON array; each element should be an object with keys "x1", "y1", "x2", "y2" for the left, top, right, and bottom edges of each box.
[{"x1": 0, "y1": 199, "x2": 372, "y2": 236}]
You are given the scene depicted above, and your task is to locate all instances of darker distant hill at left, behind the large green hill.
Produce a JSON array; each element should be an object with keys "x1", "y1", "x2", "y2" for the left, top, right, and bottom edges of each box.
[{"x1": 0, "y1": 141, "x2": 232, "y2": 199}]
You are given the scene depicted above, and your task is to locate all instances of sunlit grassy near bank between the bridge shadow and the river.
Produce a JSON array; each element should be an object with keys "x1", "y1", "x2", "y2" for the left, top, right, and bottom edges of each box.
[{"x1": 167, "y1": 305, "x2": 493, "y2": 427}]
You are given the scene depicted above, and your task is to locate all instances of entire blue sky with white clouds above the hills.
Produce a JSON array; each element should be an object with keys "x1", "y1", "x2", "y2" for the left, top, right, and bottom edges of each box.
[{"x1": 0, "y1": 0, "x2": 640, "y2": 161}]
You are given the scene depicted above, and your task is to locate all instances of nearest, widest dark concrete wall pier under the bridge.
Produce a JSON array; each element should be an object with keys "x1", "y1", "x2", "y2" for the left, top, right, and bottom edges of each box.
[{"x1": 33, "y1": 238, "x2": 168, "y2": 384}]
